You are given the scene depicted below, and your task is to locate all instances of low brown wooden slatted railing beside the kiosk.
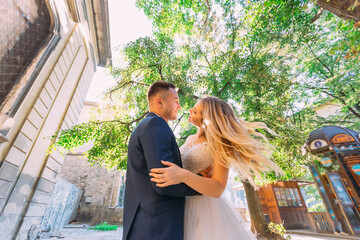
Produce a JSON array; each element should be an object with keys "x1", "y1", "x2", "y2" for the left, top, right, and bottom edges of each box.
[{"x1": 306, "y1": 212, "x2": 334, "y2": 233}]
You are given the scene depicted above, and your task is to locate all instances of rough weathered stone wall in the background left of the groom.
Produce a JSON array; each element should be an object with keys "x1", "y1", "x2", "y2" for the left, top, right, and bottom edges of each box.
[{"x1": 60, "y1": 154, "x2": 123, "y2": 225}]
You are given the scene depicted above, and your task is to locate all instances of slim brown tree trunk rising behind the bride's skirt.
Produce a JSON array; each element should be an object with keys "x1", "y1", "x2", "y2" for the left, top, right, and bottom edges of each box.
[{"x1": 243, "y1": 182, "x2": 284, "y2": 239}]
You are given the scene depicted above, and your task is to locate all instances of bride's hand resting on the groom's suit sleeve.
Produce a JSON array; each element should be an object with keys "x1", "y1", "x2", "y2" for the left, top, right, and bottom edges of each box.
[{"x1": 149, "y1": 161, "x2": 186, "y2": 187}]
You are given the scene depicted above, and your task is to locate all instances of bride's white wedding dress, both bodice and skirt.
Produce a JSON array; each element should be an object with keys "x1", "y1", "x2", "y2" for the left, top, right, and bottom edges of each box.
[{"x1": 180, "y1": 142, "x2": 256, "y2": 240}]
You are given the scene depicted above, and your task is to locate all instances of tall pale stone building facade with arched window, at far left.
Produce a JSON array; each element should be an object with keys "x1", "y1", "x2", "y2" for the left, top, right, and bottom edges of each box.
[{"x1": 0, "y1": 0, "x2": 111, "y2": 240}]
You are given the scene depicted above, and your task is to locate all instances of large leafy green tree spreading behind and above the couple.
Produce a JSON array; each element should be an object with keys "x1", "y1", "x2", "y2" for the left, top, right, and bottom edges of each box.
[{"x1": 53, "y1": 0, "x2": 360, "y2": 236}]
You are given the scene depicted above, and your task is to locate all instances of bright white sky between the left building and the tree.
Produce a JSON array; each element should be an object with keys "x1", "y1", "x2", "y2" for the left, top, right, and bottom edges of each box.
[{"x1": 85, "y1": 0, "x2": 151, "y2": 102}]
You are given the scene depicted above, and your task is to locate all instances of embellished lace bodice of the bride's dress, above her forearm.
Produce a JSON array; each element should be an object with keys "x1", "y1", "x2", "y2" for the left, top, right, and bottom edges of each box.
[{"x1": 180, "y1": 142, "x2": 213, "y2": 173}]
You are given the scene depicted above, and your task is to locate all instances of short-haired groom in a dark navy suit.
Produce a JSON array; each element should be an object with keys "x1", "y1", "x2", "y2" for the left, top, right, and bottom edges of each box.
[{"x1": 123, "y1": 81, "x2": 199, "y2": 240}]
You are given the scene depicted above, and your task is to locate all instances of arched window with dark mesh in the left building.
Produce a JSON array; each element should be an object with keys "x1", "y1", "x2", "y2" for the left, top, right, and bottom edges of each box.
[{"x1": 0, "y1": 0, "x2": 51, "y2": 103}]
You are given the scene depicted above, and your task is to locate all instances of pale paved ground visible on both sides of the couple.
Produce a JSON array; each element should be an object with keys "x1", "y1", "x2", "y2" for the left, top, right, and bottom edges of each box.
[{"x1": 45, "y1": 225, "x2": 360, "y2": 240}]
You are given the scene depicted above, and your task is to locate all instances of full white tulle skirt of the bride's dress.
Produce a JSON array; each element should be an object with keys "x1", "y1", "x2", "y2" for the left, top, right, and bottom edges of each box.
[{"x1": 184, "y1": 196, "x2": 256, "y2": 240}]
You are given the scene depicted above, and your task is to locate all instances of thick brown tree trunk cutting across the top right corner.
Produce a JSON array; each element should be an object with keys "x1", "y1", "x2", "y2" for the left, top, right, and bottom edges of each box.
[{"x1": 316, "y1": 0, "x2": 360, "y2": 22}]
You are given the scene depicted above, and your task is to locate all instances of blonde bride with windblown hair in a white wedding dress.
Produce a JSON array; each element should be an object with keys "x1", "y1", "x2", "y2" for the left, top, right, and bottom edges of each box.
[{"x1": 150, "y1": 96, "x2": 281, "y2": 240}]
